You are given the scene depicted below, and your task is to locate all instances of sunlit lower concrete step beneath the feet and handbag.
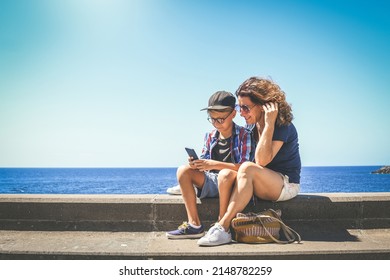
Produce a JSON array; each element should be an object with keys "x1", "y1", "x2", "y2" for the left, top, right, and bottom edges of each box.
[{"x1": 0, "y1": 229, "x2": 390, "y2": 259}]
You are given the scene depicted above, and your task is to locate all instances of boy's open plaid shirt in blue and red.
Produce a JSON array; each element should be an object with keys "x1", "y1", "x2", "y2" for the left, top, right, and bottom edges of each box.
[{"x1": 200, "y1": 122, "x2": 256, "y2": 164}]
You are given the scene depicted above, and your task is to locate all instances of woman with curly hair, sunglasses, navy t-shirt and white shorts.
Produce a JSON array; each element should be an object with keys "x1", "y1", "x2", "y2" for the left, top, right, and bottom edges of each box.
[{"x1": 198, "y1": 77, "x2": 301, "y2": 246}]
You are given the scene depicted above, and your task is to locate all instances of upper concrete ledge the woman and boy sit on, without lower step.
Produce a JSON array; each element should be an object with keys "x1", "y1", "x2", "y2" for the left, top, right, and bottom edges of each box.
[{"x1": 0, "y1": 193, "x2": 390, "y2": 232}]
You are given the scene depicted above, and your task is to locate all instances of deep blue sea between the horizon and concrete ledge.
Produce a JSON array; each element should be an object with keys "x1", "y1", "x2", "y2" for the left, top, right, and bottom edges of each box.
[{"x1": 0, "y1": 166, "x2": 390, "y2": 194}]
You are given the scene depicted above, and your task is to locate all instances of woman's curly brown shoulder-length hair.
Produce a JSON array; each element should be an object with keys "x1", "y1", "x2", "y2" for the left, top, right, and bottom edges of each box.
[{"x1": 236, "y1": 77, "x2": 294, "y2": 126}]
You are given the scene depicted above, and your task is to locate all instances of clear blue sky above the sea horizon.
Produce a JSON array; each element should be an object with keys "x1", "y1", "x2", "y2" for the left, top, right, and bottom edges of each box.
[{"x1": 0, "y1": 0, "x2": 390, "y2": 167}]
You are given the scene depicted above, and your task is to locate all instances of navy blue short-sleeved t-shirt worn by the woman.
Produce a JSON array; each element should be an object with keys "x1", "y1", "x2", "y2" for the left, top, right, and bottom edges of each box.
[{"x1": 266, "y1": 123, "x2": 301, "y2": 184}]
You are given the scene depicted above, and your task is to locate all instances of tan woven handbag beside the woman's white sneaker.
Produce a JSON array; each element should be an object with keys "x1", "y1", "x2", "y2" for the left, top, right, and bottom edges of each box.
[{"x1": 231, "y1": 209, "x2": 301, "y2": 244}]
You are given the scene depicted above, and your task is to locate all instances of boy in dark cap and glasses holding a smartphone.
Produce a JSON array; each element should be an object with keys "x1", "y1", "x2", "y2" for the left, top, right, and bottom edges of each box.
[{"x1": 166, "y1": 91, "x2": 255, "y2": 239}]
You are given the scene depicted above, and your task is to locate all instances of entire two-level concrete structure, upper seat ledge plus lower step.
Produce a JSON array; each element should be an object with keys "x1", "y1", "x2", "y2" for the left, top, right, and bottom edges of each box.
[{"x1": 0, "y1": 193, "x2": 390, "y2": 260}]
